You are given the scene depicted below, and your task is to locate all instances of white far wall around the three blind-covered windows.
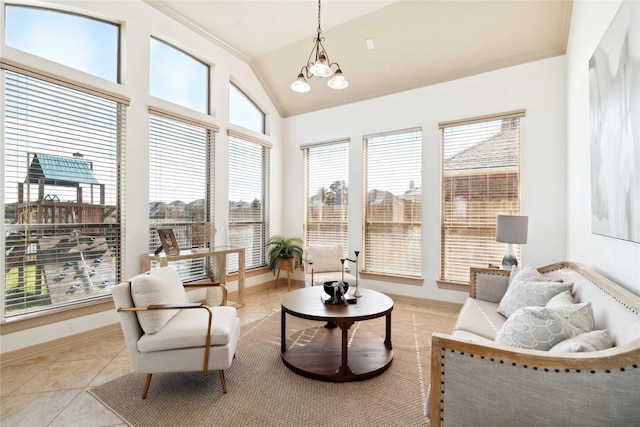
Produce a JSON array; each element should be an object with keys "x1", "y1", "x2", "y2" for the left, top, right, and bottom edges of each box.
[{"x1": 284, "y1": 57, "x2": 567, "y2": 302}]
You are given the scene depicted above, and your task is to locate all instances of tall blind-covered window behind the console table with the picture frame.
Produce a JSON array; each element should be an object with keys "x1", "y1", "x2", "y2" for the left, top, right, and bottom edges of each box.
[{"x1": 149, "y1": 107, "x2": 218, "y2": 280}]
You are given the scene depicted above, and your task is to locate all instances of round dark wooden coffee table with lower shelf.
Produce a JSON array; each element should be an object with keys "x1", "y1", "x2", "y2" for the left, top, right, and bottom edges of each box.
[{"x1": 280, "y1": 286, "x2": 393, "y2": 381}]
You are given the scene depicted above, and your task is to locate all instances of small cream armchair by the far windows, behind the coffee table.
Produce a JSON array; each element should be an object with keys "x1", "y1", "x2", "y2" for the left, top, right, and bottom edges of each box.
[{"x1": 304, "y1": 245, "x2": 357, "y2": 287}]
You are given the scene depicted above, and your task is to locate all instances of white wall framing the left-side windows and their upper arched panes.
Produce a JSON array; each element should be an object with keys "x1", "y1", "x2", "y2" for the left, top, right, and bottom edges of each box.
[{"x1": 0, "y1": 0, "x2": 283, "y2": 352}]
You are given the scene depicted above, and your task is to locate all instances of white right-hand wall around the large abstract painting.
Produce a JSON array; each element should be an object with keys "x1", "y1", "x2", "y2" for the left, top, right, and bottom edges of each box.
[{"x1": 566, "y1": 1, "x2": 640, "y2": 295}]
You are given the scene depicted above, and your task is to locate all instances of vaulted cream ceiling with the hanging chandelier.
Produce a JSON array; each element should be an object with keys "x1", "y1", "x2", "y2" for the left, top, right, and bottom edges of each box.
[{"x1": 145, "y1": 0, "x2": 573, "y2": 117}]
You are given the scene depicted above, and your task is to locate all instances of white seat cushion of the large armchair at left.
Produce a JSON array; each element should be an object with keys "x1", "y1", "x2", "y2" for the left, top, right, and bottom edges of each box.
[{"x1": 138, "y1": 307, "x2": 239, "y2": 353}]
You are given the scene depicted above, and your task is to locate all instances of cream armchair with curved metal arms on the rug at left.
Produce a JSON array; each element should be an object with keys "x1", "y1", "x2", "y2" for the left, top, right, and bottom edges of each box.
[{"x1": 112, "y1": 267, "x2": 240, "y2": 399}]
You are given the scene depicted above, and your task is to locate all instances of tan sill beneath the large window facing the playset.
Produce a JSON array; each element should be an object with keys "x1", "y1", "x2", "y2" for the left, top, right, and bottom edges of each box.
[{"x1": 0, "y1": 296, "x2": 115, "y2": 335}]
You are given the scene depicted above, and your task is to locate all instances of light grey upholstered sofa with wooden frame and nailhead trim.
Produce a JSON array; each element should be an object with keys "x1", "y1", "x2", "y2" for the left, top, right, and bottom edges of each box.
[{"x1": 425, "y1": 262, "x2": 640, "y2": 427}]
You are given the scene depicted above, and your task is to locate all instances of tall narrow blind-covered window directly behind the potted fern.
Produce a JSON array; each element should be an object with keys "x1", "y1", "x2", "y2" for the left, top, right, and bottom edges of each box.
[{"x1": 228, "y1": 131, "x2": 271, "y2": 268}]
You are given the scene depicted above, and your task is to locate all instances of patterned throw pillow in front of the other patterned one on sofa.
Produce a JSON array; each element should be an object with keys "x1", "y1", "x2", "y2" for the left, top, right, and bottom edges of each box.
[{"x1": 495, "y1": 302, "x2": 594, "y2": 350}]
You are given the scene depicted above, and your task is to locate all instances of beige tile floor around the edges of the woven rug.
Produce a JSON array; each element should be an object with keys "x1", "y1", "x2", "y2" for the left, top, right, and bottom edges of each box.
[{"x1": 0, "y1": 284, "x2": 460, "y2": 427}]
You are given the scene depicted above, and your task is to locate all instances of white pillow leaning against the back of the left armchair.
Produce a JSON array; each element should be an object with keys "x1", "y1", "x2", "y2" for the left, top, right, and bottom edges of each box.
[{"x1": 131, "y1": 267, "x2": 187, "y2": 334}]
